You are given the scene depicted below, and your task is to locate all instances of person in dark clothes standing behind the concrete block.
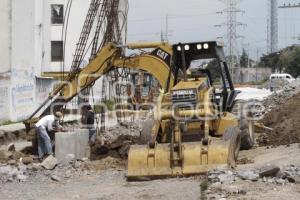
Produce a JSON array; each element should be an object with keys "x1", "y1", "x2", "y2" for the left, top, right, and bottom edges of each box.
[{"x1": 83, "y1": 105, "x2": 96, "y2": 143}]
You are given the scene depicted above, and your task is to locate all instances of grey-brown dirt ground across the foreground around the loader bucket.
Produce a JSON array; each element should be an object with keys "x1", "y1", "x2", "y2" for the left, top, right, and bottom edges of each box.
[{"x1": 0, "y1": 144, "x2": 300, "y2": 200}]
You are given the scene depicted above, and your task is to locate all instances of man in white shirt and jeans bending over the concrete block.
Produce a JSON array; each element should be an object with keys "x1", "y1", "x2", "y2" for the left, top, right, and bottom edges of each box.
[{"x1": 35, "y1": 112, "x2": 63, "y2": 159}]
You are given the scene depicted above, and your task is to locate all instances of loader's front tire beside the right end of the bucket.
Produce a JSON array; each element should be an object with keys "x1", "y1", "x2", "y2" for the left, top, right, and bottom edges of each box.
[{"x1": 222, "y1": 126, "x2": 241, "y2": 168}]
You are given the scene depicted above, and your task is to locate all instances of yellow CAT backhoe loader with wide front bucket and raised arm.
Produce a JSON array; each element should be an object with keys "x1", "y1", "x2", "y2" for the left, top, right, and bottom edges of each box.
[{"x1": 24, "y1": 42, "x2": 251, "y2": 179}]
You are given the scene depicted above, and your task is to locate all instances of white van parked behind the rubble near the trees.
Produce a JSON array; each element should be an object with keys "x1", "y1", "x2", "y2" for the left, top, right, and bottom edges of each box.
[{"x1": 269, "y1": 74, "x2": 295, "y2": 91}]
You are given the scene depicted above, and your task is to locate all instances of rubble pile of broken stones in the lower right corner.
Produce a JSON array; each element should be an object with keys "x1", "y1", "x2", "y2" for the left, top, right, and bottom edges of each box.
[{"x1": 207, "y1": 165, "x2": 300, "y2": 199}]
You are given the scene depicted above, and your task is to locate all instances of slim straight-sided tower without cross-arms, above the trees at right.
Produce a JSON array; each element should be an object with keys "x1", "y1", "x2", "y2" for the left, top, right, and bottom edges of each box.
[{"x1": 267, "y1": 0, "x2": 278, "y2": 53}]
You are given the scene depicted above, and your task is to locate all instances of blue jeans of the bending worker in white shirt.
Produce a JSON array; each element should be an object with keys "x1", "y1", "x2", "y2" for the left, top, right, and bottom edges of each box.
[{"x1": 36, "y1": 126, "x2": 53, "y2": 158}]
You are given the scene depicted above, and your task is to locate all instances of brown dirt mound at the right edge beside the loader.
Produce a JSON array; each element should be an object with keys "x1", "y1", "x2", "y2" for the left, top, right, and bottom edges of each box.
[{"x1": 258, "y1": 93, "x2": 300, "y2": 146}]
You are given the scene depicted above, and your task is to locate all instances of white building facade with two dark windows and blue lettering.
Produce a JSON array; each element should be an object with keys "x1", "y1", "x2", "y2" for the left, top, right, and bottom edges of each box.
[{"x1": 0, "y1": 0, "x2": 90, "y2": 123}]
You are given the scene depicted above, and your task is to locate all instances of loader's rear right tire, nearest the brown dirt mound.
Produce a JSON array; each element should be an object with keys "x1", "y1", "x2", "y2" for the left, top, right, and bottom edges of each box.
[{"x1": 240, "y1": 119, "x2": 254, "y2": 150}]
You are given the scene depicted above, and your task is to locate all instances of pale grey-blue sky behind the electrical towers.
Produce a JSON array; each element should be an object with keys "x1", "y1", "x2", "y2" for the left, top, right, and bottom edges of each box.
[{"x1": 127, "y1": 0, "x2": 300, "y2": 59}]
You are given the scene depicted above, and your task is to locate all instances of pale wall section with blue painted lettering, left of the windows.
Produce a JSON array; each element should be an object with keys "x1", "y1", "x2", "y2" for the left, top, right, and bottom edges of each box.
[{"x1": 0, "y1": 0, "x2": 51, "y2": 121}]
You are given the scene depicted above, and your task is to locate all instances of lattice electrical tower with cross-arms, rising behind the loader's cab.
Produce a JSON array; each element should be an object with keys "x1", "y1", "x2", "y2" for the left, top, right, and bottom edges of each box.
[{"x1": 216, "y1": 0, "x2": 245, "y2": 81}]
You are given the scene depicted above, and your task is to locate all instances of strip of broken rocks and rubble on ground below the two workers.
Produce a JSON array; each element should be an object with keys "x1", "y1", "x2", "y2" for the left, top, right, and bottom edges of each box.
[{"x1": 0, "y1": 148, "x2": 125, "y2": 184}]
